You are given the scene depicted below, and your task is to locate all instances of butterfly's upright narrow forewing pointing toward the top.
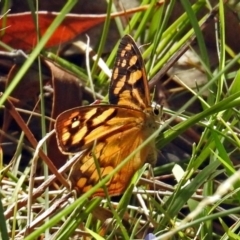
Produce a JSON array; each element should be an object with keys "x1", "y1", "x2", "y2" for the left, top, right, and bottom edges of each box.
[{"x1": 109, "y1": 35, "x2": 151, "y2": 110}]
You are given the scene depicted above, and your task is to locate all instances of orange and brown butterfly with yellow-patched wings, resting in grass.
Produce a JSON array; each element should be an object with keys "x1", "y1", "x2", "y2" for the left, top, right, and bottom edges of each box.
[{"x1": 55, "y1": 35, "x2": 161, "y2": 196}]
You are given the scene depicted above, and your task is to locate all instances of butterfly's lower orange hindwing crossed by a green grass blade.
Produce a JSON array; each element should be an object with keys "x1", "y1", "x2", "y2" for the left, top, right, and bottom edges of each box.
[{"x1": 70, "y1": 120, "x2": 154, "y2": 196}]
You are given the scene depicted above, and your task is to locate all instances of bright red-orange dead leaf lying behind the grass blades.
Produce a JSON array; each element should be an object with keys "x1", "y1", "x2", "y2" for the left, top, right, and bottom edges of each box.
[{"x1": 0, "y1": 5, "x2": 156, "y2": 51}]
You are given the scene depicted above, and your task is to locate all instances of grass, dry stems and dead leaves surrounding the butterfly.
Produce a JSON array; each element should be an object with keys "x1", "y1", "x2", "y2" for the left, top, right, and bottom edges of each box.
[{"x1": 0, "y1": 0, "x2": 240, "y2": 240}]
